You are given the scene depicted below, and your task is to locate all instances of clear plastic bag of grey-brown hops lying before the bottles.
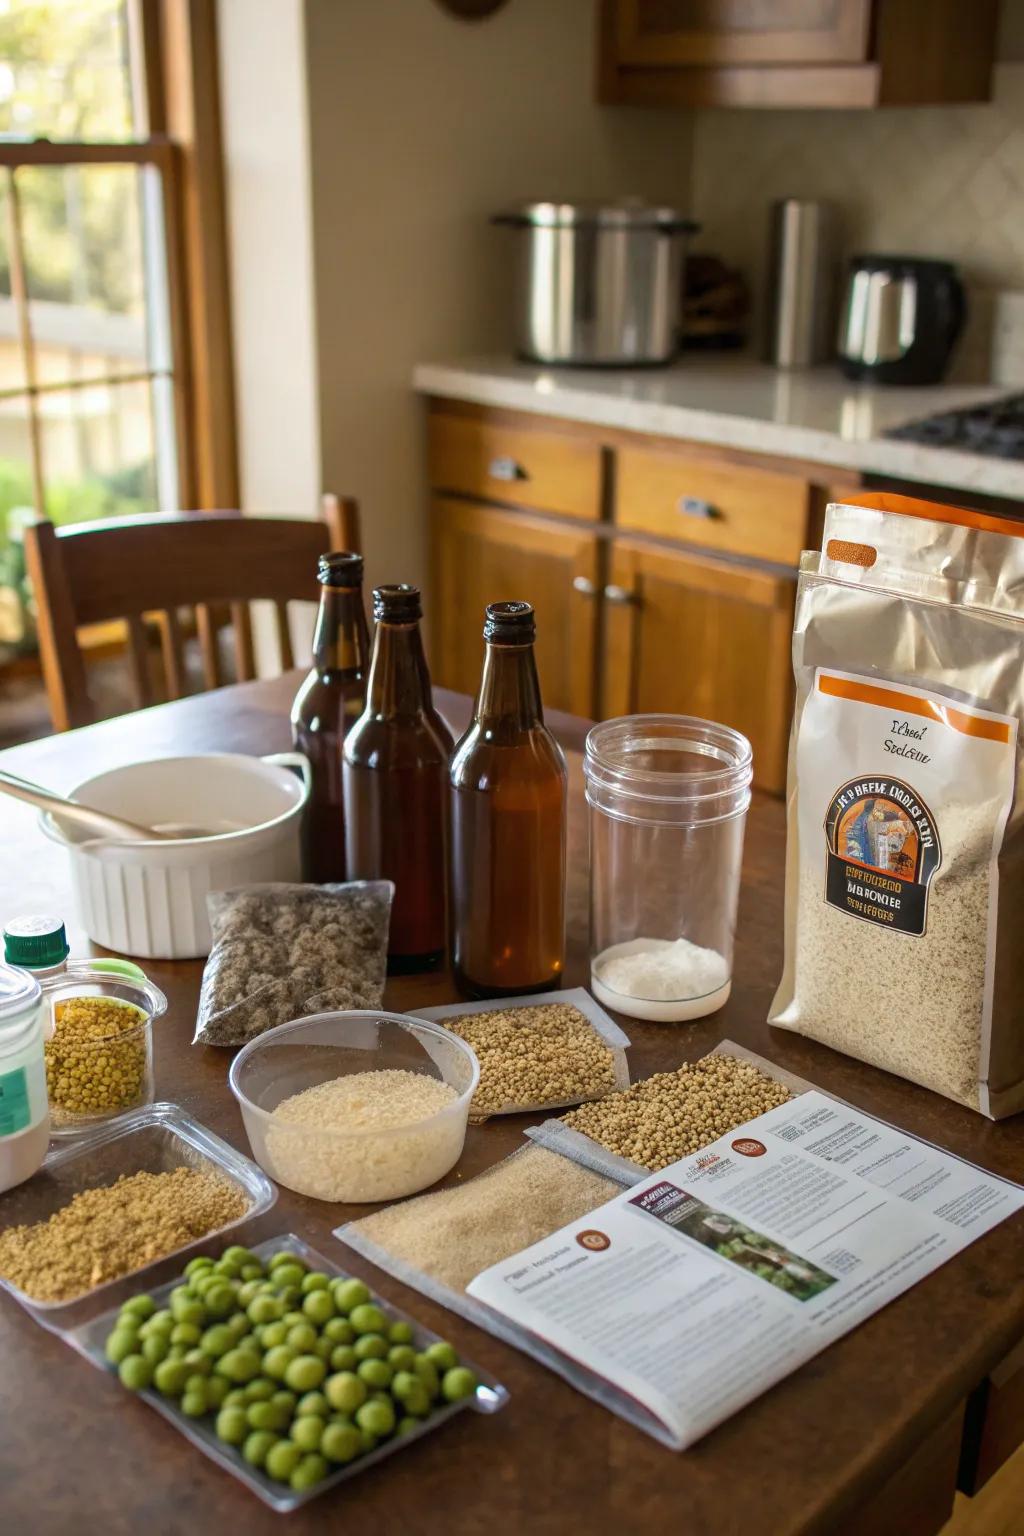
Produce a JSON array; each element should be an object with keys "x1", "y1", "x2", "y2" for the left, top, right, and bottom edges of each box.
[{"x1": 192, "y1": 880, "x2": 395, "y2": 1046}]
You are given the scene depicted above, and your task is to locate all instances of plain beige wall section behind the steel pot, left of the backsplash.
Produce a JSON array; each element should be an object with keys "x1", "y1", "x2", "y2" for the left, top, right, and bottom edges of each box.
[{"x1": 306, "y1": 0, "x2": 689, "y2": 599}]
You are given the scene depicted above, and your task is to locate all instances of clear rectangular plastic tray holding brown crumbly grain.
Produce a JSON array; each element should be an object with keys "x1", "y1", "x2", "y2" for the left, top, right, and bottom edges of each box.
[{"x1": 0, "y1": 1104, "x2": 278, "y2": 1333}]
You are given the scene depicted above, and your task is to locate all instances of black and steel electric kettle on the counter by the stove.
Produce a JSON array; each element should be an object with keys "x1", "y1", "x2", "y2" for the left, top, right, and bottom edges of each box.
[{"x1": 838, "y1": 257, "x2": 966, "y2": 384}]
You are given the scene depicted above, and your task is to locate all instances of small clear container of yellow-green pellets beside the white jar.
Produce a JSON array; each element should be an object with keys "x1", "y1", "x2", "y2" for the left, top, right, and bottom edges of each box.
[{"x1": 43, "y1": 960, "x2": 167, "y2": 1137}]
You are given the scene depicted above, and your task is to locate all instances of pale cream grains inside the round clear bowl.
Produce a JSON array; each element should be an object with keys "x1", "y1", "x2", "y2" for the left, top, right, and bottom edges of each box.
[{"x1": 259, "y1": 1069, "x2": 468, "y2": 1201}]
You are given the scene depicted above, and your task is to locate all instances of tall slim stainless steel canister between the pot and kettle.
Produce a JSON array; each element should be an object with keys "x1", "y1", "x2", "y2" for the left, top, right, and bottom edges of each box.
[{"x1": 766, "y1": 197, "x2": 837, "y2": 369}]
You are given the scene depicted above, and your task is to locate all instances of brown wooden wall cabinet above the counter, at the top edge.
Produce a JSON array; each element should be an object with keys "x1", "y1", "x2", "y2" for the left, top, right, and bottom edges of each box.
[{"x1": 597, "y1": 0, "x2": 998, "y2": 108}]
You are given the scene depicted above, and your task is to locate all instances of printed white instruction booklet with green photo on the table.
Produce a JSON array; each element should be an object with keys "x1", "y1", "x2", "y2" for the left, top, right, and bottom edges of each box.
[{"x1": 467, "y1": 1092, "x2": 1024, "y2": 1450}]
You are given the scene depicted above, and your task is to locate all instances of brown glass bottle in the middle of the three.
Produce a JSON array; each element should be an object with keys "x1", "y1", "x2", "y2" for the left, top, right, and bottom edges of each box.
[{"x1": 342, "y1": 584, "x2": 451, "y2": 972}]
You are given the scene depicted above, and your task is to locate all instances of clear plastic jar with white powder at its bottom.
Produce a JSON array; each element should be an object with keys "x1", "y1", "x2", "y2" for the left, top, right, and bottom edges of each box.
[{"x1": 583, "y1": 714, "x2": 752, "y2": 1023}]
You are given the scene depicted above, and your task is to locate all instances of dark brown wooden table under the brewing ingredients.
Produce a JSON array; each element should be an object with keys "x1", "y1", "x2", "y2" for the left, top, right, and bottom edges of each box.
[{"x1": 0, "y1": 674, "x2": 1024, "y2": 1536}]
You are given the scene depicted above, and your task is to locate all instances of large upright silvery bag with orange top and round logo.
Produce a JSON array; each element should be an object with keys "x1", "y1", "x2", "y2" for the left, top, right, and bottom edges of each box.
[{"x1": 771, "y1": 495, "x2": 1024, "y2": 1120}]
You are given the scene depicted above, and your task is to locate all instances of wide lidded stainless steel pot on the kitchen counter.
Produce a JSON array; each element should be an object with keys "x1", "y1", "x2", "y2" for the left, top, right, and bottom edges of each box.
[{"x1": 494, "y1": 203, "x2": 699, "y2": 367}]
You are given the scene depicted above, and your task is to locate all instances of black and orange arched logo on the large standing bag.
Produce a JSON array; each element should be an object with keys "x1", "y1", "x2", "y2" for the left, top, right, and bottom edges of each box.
[{"x1": 824, "y1": 779, "x2": 943, "y2": 934}]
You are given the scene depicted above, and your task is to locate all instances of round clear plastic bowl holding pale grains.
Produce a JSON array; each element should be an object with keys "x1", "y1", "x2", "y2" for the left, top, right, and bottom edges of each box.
[{"x1": 229, "y1": 1009, "x2": 481, "y2": 1204}]
